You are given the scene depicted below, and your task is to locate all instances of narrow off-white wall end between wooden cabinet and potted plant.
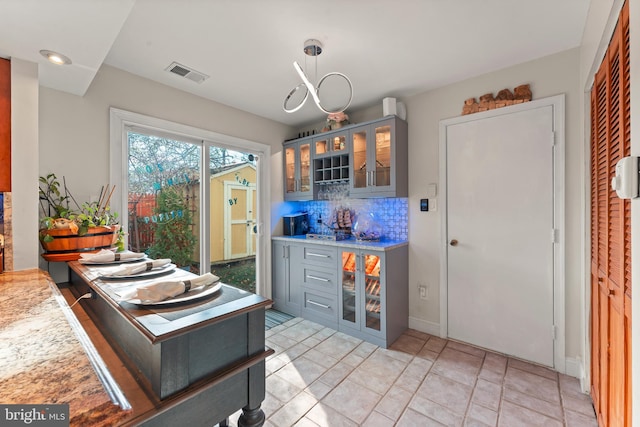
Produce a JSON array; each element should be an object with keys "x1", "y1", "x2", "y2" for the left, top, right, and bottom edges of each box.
[{"x1": 11, "y1": 58, "x2": 39, "y2": 270}]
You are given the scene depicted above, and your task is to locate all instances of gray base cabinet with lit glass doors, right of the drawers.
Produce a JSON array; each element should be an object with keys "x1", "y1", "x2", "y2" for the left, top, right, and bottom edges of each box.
[{"x1": 338, "y1": 246, "x2": 409, "y2": 348}]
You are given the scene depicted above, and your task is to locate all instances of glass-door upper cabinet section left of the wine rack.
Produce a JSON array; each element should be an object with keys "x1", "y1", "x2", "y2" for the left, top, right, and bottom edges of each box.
[{"x1": 283, "y1": 138, "x2": 313, "y2": 200}]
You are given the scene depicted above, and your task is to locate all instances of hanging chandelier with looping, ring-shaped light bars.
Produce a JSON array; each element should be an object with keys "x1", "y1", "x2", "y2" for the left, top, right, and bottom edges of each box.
[{"x1": 283, "y1": 39, "x2": 353, "y2": 114}]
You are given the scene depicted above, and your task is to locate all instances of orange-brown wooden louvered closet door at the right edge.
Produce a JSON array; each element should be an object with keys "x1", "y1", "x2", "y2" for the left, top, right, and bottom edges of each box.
[{"x1": 591, "y1": 1, "x2": 631, "y2": 426}]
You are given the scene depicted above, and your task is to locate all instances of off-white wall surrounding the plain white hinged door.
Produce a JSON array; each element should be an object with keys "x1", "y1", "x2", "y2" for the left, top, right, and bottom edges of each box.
[{"x1": 405, "y1": 49, "x2": 583, "y2": 368}]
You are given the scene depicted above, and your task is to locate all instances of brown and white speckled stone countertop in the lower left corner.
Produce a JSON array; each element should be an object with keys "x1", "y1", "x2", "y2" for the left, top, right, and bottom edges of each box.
[{"x1": 0, "y1": 269, "x2": 130, "y2": 426}]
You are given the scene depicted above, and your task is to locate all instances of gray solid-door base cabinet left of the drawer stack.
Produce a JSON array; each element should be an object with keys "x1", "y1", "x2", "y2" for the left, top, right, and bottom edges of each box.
[{"x1": 271, "y1": 240, "x2": 302, "y2": 316}]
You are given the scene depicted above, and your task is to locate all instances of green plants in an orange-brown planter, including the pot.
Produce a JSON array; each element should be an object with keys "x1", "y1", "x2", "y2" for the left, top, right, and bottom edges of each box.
[{"x1": 39, "y1": 173, "x2": 123, "y2": 261}]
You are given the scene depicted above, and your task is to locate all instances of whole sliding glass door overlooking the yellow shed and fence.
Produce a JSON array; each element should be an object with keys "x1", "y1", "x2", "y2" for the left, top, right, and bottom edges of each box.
[{"x1": 126, "y1": 128, "x2": 258, "y2": 292}]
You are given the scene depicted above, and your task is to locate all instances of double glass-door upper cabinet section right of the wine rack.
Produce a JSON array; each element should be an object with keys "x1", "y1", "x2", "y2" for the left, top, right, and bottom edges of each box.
[{"x1": 349, "y1": 116, "x2": 409, "y2": 197}]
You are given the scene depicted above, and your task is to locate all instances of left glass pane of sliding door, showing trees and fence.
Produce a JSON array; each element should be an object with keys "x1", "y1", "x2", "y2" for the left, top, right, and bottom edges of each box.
[{"x1": 128, "y1": 132, "x2": 201, "y2": 273}]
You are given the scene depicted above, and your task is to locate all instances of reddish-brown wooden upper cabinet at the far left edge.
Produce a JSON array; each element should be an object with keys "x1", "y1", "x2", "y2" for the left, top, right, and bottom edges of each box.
[{"x1": 0, "y1": 58, "x2": 11, "y2": 192}]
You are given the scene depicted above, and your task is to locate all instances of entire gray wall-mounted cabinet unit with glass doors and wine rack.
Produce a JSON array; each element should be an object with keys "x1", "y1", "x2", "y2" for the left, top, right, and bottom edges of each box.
[{"x1": 283, "y1": 116, "x2": 409, "y2": 200}]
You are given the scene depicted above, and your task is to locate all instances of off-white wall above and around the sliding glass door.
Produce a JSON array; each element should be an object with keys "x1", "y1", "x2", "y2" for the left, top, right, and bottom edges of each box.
[{"x1": 36, "y1": 66, "x2": 294, "y2": 280}]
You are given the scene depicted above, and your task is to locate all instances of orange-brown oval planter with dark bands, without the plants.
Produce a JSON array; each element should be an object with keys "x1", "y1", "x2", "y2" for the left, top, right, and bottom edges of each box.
[{"x1": 40, "y1": 224, "x2": 120, "y2": 261}]
